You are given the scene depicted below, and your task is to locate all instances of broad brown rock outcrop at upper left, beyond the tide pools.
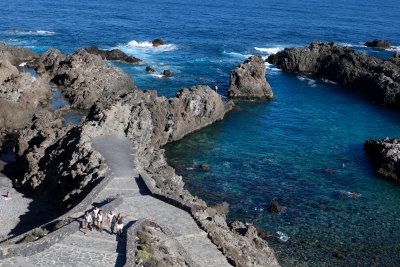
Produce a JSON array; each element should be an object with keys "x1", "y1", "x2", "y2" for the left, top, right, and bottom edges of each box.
[{"x1": 36, "y1": 49, "x2": 137, "y2": 109}]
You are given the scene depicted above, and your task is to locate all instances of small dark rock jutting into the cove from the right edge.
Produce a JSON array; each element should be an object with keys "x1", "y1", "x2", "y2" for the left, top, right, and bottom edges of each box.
[{"x1": 364, "y1": 138, "x2": 400, "y2": 182}]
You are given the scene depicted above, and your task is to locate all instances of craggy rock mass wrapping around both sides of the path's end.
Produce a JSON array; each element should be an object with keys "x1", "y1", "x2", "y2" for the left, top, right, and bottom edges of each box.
[{"x1": 17, "y1": 86, "x2": 232, "y2": 207}]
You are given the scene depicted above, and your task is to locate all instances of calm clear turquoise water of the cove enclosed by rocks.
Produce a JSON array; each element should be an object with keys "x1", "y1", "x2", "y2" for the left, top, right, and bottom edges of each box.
[{"x1": 166, "y1": 73, "x2": 400, "y2": 266}]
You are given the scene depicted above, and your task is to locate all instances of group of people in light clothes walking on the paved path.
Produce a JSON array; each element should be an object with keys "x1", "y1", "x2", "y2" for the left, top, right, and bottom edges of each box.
[{"x1": 84, "y1": 207, "x2": 124, "y2": 237}]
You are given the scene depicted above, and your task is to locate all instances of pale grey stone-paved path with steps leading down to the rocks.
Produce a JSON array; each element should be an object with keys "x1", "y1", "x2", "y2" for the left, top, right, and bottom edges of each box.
[{"x1": 0, "y1": 136, "x2": 231, "y2": 267}]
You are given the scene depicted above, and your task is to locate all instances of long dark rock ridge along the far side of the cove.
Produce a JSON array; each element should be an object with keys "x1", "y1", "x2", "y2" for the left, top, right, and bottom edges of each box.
[{"x1": 268, "y1": 42, "x2": 400, "y2": 108}]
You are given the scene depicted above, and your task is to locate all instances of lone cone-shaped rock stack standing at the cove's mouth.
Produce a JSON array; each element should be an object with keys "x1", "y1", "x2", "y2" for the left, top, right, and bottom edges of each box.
[{"x1": 227, "y1": 56, "x2": 274, "y2": 100}]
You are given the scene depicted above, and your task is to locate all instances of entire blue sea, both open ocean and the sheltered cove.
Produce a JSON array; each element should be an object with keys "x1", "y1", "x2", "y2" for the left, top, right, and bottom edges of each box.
[{"x1": 0, "y1": 0, "x2": 400, "y2": 266}]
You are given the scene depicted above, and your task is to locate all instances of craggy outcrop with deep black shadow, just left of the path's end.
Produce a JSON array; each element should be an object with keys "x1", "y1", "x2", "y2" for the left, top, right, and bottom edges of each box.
[{"x1": 16, "y1": 111, "x2": 106, "y2": 209}]
